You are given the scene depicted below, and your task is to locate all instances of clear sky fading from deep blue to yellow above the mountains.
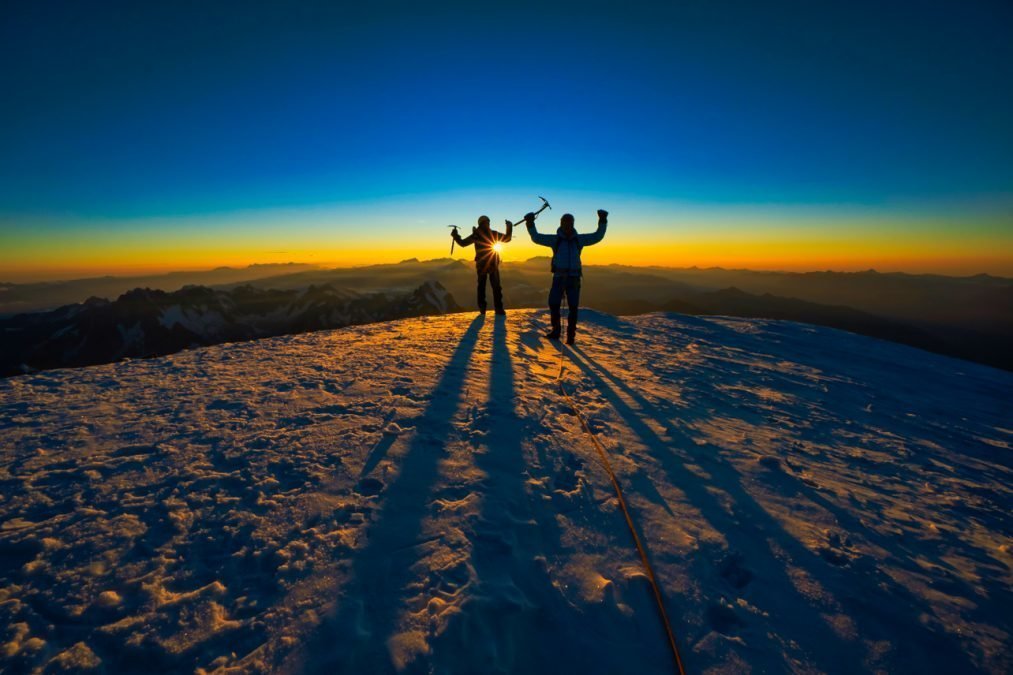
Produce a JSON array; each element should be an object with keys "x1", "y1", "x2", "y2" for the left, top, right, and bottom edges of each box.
[{"x1": 0, "y1": 2, "x2": 1013, "y2": 278}]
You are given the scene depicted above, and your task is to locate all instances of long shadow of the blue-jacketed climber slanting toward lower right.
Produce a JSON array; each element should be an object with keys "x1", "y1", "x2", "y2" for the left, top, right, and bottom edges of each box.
[{"x1": 571, "y1": 348, "x2": 977, "y2": 673}]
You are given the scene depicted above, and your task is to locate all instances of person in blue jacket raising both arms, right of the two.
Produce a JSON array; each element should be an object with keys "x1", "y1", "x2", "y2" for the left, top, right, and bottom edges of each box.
[{"x1": 524, "y1": 209, "x2": 609, "y2": 345}]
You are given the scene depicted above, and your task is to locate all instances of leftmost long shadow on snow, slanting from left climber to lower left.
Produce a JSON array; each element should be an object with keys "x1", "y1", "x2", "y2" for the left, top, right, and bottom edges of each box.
[{"x1": 293, "y1": 316, "x2": 484, "y2": 673}]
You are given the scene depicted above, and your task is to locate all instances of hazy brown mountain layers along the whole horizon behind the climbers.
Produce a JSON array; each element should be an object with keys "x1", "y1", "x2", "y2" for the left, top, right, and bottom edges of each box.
[{"x1": 0, "y1": 257, "x2": 1013, "y2": 370}]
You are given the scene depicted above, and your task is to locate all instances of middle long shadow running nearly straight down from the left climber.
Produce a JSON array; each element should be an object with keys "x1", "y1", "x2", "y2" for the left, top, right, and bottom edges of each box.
[{"x1": 434, "y1": 319, "x2": 667, "y2": 672}]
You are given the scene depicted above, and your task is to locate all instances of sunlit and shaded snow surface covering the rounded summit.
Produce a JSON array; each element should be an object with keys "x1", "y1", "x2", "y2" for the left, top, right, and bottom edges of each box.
[{"x1": 0, "y1": 311, "x2": 1013, "y2": 673}]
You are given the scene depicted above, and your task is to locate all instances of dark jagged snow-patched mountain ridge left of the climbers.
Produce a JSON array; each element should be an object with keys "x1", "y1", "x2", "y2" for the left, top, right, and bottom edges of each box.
[{"x1": 0, "y1": 281, "x2": 460, "y2": 376}]
